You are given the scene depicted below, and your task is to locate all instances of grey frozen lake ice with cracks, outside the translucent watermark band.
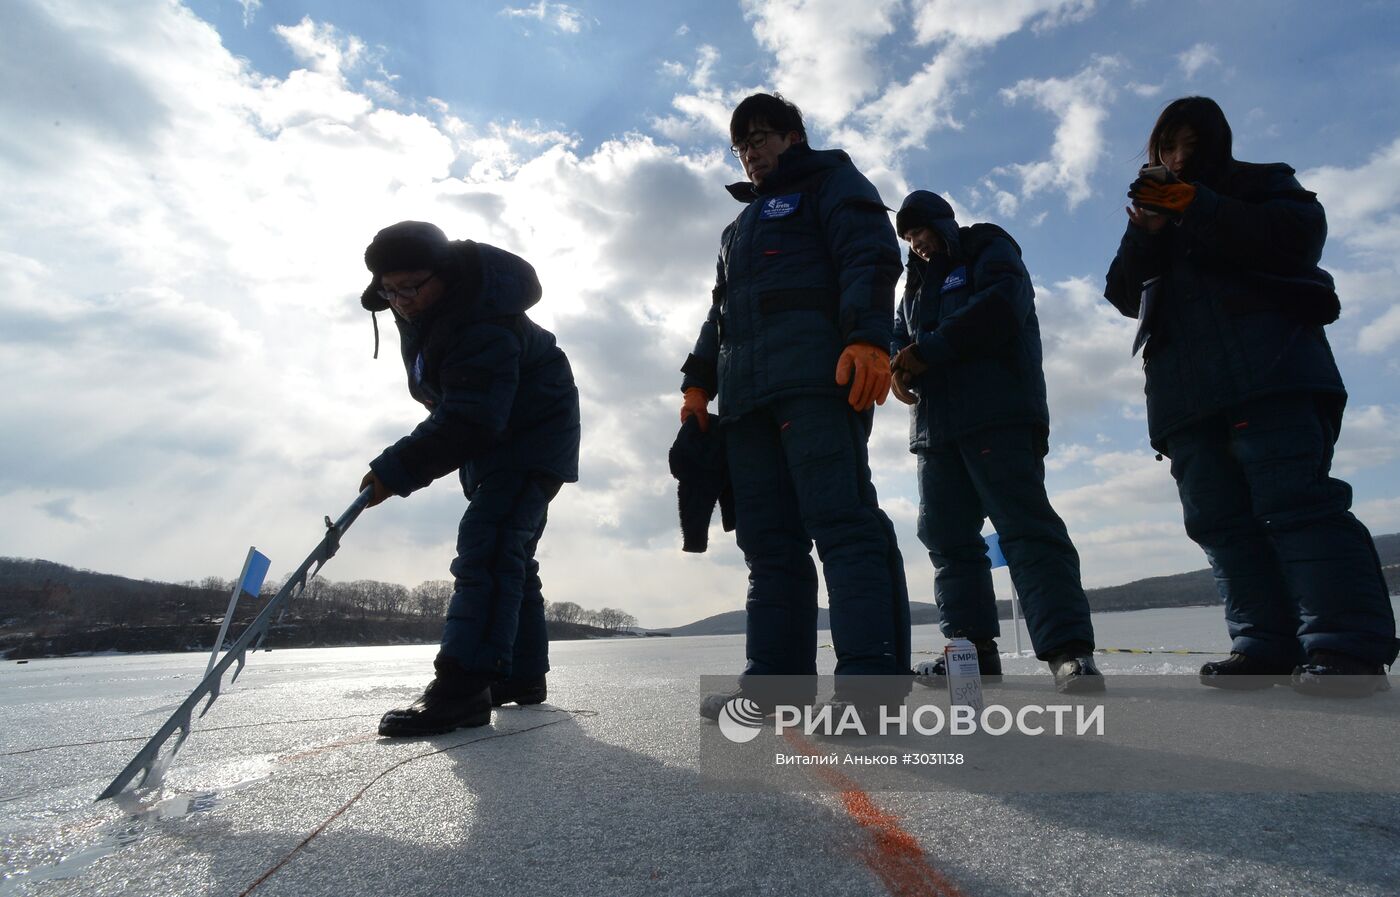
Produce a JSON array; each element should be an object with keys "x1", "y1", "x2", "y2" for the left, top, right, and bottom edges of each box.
[{"x1": 0, "y1": 607, "x2": 1400, "y2": 897}]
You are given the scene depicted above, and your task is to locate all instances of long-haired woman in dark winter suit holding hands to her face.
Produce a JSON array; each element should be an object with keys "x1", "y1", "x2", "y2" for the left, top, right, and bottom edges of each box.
[{"x1": 1105, "y1": 97, "x2": 1397, "y2": 695}]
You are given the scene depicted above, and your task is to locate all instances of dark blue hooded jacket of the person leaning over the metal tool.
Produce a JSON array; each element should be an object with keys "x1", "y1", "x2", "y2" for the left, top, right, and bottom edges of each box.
[{"x1": 365, "y1": 241, "x2": 580, "y2": 495}]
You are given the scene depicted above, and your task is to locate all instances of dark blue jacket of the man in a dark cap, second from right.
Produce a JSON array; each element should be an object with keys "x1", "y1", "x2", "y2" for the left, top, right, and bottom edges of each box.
[{"x1": 890, "y1": 190, "x2": 1050, "y2": 452}]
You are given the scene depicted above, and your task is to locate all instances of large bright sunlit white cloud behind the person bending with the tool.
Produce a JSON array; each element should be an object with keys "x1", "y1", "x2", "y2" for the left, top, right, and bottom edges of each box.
[{"x1": 0, "y1": 3, "x2": 743, "y2": 624}]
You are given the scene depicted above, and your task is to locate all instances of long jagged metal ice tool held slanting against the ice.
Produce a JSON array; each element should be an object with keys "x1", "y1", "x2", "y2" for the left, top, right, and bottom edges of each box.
[{"x1": 97, "y1": 486, "x2": 374, "y2": 800}]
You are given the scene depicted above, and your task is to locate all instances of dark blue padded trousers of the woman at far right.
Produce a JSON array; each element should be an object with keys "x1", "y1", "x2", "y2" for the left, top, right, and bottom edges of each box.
[{"x1": 1165, "y1": 393, "x2": 1397, "y2": 665}]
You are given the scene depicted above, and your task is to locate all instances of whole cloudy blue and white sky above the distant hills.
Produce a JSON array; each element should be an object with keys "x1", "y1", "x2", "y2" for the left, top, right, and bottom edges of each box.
[{"x1": 0, "y1": 0, "x2": 1400, "y2": 627}]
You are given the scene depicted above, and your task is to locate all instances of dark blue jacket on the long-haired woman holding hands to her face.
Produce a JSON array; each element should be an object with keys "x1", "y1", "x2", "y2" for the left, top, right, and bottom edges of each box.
[{"x1": 1105, "y1": 162, "x2": 1347, "y2": 452}]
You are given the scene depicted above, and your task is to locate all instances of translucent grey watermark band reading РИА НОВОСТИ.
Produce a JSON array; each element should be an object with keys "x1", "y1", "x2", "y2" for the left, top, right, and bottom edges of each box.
[{"x1": 693, "y1": 674, "x2": 1400, "y2": 793}]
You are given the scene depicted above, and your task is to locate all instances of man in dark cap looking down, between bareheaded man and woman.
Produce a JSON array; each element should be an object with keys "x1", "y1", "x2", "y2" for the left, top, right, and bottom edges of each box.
[{"x1": 890, "y1": 190, "x2": 1103, "y2": 691}]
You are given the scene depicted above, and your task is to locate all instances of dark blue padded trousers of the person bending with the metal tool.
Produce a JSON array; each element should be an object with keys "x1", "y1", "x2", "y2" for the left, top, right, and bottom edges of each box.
[{"x1": 438, "y1": 472, "x2": 561, "y2": 679}]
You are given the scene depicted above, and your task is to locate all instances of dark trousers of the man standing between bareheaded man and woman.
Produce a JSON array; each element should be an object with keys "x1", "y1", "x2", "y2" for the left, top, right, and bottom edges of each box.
[{"x1": 917, "y1": 427, "x2": 1093, "y2": 661}]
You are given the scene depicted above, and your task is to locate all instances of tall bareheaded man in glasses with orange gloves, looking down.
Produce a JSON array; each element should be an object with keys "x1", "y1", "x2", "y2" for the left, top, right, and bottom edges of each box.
[{"x1": 680, "y1": 94, "x2": 909, "y2": 718}]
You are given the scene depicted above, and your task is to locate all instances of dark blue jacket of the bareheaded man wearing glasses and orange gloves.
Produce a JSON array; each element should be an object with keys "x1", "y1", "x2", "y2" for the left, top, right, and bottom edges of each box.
[{"x1": 682, "y1": 143, "x2": 900, "y2": 418}]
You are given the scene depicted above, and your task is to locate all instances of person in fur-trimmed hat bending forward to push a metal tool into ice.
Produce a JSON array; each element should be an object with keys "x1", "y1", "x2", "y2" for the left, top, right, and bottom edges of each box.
[{"x1": 360, "y1": 221, "x2": 580, "y2": 736}]
